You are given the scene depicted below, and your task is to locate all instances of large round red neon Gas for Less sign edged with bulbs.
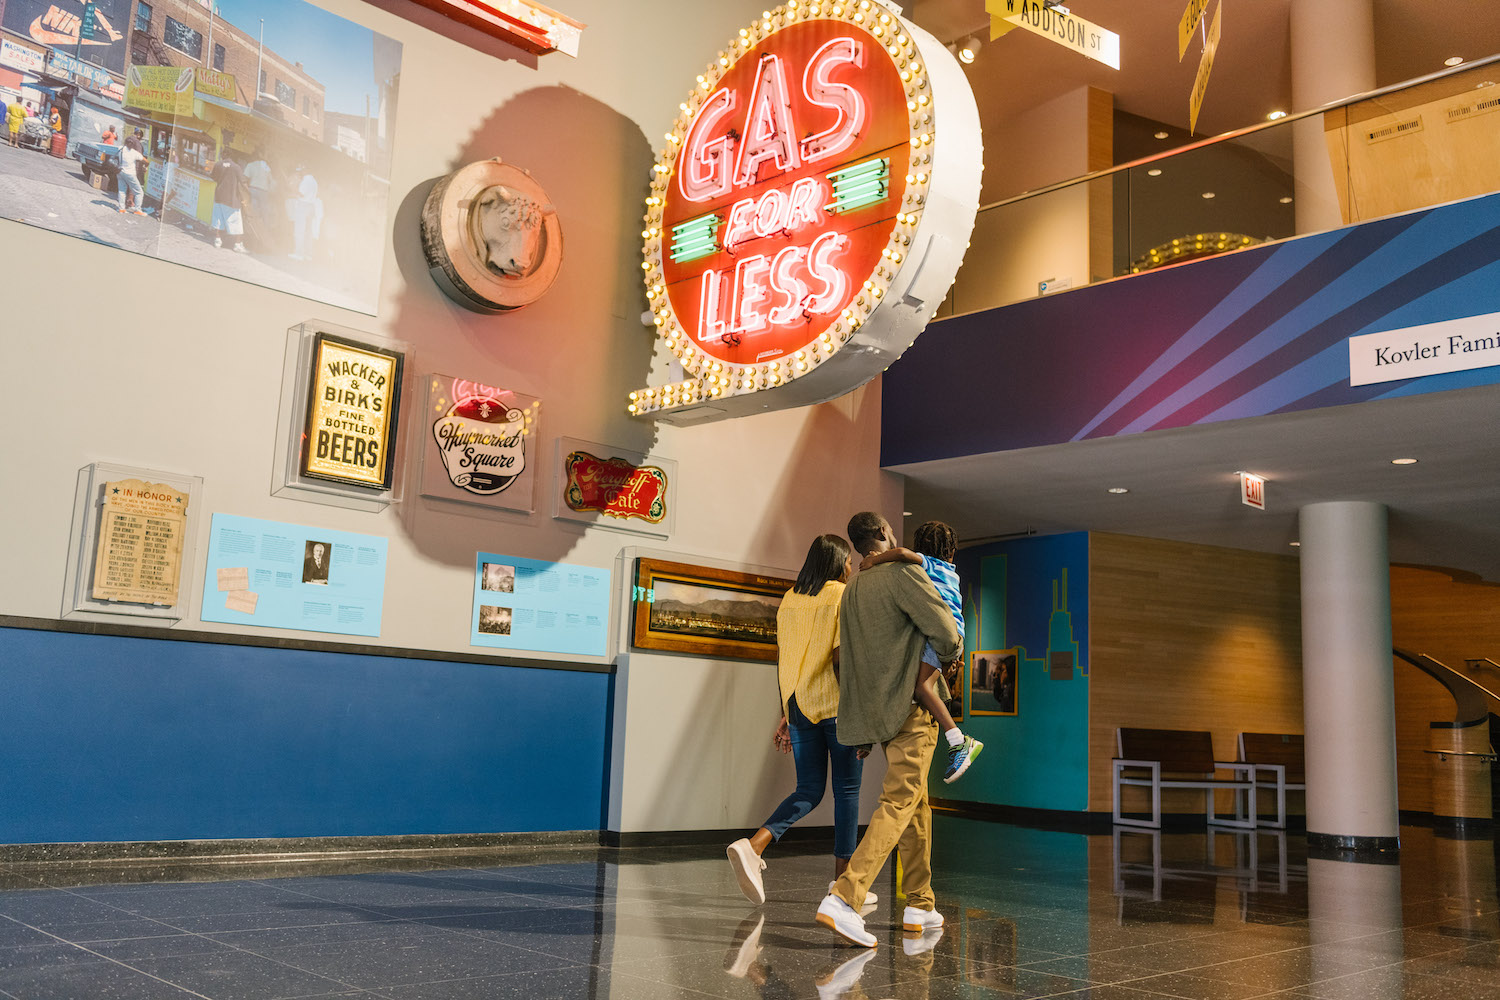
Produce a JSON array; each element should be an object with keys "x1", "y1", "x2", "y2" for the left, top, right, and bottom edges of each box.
[{"x1": 630, "y1": 0, "x2": 981, "y2": 421}]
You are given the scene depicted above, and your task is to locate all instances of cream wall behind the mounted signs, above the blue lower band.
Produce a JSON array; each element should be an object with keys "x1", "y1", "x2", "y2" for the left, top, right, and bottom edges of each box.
[{"x1": 0, "y1": 0, "x2": 900, "y2": 829}]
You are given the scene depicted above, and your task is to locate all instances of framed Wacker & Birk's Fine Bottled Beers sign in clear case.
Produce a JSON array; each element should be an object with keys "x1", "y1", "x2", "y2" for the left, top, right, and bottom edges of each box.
[{"x1": 272, "y1": 321, "x2": 411, "y2": 510}]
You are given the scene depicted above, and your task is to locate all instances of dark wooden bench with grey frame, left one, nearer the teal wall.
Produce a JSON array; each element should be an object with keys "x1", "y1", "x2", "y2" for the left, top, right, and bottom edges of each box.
[{"x1": 1113, "y1": 727, "x2": 1256, "y2": 829}]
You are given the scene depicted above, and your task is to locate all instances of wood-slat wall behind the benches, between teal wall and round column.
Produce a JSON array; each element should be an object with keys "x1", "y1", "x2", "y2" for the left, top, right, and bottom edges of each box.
[{"x1": 1089, "y1": 534, "x2": 1308, "y2": 813}]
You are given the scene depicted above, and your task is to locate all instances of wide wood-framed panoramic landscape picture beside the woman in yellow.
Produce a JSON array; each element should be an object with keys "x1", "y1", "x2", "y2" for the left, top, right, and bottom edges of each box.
[{"x1": 630, "y1": 558, "x2": 794, "y2": 663}]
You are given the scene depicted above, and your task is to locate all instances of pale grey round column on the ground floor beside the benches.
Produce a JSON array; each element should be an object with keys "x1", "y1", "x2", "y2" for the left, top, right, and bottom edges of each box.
[{"x1": 1298, "y1": 501, "x2": 1400, "y2": 855}]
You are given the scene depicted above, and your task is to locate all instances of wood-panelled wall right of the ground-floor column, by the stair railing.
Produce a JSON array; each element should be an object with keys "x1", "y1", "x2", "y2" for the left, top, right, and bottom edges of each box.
[{"x1": 1391, "y1": 567, "x2": 1500, "y2": 813}]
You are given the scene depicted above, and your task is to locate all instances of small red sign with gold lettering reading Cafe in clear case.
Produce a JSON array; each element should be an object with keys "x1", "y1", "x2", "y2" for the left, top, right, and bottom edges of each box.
[{"x1": 555, "y1": 438, "x2": 677, "y2": 538}]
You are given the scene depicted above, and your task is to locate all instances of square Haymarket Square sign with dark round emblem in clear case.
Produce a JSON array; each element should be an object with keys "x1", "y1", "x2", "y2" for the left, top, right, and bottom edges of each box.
[{"x1": 417, "y1": 373, "x2": 542, "y2": 513}]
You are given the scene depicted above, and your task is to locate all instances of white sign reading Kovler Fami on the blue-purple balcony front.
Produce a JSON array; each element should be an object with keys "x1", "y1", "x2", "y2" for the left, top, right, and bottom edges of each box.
[{"x1": 1349, "y1": 312, "x2": 1500, "y2": 385}]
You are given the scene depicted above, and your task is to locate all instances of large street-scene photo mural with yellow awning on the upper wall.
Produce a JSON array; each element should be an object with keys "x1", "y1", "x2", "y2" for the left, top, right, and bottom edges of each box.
[{"x1": 0, "y1": 0, "x2": 402, "y2": 315}]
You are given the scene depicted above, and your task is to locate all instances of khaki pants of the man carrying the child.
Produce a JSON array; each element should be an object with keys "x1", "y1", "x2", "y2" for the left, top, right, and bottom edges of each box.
[{"x1": 834, "y1": 705, "x2": 938, "y2": 912}]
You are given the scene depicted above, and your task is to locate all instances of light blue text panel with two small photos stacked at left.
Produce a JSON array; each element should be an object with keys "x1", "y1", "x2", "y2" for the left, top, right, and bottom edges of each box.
[{"x1": 470, "y1": 552, "x2": 609, "y2": 657}]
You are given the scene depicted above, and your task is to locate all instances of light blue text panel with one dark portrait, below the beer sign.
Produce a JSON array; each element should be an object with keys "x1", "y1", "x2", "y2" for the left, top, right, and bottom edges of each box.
[{"x1": 201, "y1": 514, "x2": 387, "y2": 637}]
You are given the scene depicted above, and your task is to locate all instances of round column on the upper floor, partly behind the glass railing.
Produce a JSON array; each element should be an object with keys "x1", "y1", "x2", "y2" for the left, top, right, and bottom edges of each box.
[{"x1": 1289, "y1": 0, "x2": 1376, "y2": 234}]
